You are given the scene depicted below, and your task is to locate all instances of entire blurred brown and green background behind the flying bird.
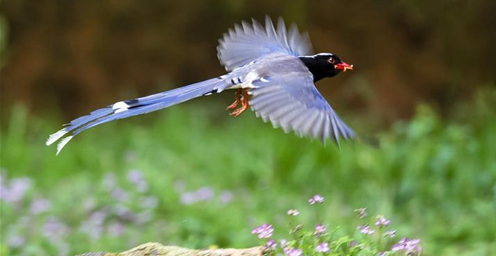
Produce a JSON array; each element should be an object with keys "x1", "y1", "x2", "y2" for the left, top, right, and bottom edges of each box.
[{"x1": 0, "y1": 0, "x2": 496, "y2": 255}]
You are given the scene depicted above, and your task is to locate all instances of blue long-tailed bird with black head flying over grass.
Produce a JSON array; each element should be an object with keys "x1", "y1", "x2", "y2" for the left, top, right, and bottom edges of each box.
[{"x1": 46, "y1": 17, "x2": 355, "y2": 154}]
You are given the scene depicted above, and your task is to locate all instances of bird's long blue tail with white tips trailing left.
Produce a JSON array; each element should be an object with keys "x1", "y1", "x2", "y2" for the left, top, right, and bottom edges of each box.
[{"x1": 46, "y1": 78, "x2": 223, "y2": 154}]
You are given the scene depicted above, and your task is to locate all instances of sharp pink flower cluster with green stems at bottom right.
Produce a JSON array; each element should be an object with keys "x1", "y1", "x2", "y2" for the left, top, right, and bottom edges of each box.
[{"x1": 252, "y1": 195, "x2": 422, "y2": 256}]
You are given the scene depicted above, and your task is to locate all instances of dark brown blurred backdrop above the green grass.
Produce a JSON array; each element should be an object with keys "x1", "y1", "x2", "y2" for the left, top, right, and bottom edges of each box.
[{"x1": 0, "y1": 0, "x2": 496, "y2": 123}]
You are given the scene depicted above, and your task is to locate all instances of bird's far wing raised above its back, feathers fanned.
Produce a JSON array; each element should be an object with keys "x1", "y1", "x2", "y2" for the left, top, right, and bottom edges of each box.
[{"x1": 217, "y1": 16, "x2": 312, "y2": 71}]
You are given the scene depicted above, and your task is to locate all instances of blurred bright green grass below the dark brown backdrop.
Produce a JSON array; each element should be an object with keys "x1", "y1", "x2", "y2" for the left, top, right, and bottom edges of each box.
[{"x1": 0, "y1": 90, "x2": 496, "y2": 255}]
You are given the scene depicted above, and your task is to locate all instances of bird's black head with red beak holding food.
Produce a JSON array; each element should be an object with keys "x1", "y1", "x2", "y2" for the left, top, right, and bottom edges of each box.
[{"x1": 299, "y1": 53, "x2": 353, "y2": 82}]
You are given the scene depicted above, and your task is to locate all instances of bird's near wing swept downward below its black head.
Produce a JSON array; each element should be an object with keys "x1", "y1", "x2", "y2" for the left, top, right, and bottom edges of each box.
[{"x1": 249, "y1": 58, "x2": 355, "y2": 145}]
